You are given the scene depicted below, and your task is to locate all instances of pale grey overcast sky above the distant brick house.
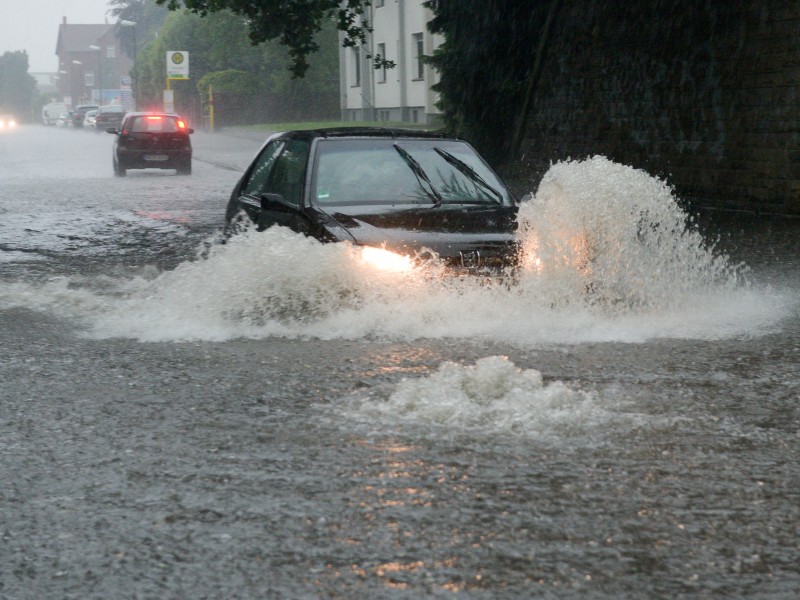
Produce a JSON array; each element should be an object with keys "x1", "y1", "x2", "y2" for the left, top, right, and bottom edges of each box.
[{"x1": 0, "y1": 0, "x2": 114, "y2": 73}]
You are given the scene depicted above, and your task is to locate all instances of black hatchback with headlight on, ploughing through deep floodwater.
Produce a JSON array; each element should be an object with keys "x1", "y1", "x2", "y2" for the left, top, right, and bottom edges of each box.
[{"x1": 225, "y1": 128, "x2": 517, "y2": 274}]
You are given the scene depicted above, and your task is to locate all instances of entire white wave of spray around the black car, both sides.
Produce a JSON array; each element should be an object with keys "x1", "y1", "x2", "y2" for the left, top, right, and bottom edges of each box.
[{"x1": 0, "y1": 157, "x2": 795, "y2": 346}]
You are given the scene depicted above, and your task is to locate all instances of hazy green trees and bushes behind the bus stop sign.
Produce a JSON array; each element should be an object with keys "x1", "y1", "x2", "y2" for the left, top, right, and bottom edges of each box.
[{"x1": 135, "y1": 11, "x2": 339, "y2": 125}]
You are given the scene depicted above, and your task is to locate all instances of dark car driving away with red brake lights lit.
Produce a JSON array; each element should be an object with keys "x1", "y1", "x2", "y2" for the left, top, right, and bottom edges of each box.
[{"x1": 108, "y1": 112, "x2": 194, "y2": 177}]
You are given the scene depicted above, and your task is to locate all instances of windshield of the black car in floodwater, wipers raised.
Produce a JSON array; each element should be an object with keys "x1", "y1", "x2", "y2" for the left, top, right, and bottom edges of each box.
[{"x1": 312, "y1": 138, "x2": 513, "y2": 206}]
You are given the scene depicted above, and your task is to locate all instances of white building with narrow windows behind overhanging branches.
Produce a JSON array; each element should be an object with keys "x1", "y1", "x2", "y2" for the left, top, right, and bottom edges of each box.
[{"x1": 339, "y1": 0, "x2": 443, "y2": 123}]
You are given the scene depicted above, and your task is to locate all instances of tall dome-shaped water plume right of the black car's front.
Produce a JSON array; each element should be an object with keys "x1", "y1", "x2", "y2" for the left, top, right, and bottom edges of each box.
[{"x1": 519, "y1": 156, "x2": 746, "y2": 313}]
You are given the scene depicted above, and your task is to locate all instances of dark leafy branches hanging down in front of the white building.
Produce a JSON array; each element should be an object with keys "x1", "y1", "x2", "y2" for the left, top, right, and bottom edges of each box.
[{"x1": 155, "y1": 0, "x2": 394, "y2": 77}]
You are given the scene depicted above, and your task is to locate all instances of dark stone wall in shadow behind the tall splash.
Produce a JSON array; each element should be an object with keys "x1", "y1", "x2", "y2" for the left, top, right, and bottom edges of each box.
[{"x1": 521, "y1": 0, "x2": 800, "y2": 215}]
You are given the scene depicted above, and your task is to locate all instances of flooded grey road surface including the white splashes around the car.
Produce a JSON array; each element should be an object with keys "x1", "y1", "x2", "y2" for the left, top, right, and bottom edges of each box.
[{"x1": 0, "y1": 126, "x2": 800, "y2": 599}]
